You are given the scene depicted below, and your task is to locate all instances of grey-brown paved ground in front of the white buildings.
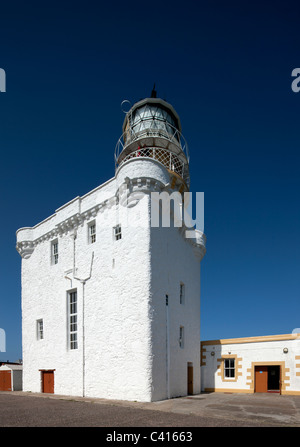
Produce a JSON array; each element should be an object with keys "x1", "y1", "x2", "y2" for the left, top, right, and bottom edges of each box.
[{"x1": 0, "y1": 391, "x2": 300, "y2": 427}]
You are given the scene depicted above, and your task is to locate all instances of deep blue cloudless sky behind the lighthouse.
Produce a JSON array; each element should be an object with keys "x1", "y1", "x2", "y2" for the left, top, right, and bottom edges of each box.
[{"x1": 0, "y1": 0, "x2": 300, "y2": 361}]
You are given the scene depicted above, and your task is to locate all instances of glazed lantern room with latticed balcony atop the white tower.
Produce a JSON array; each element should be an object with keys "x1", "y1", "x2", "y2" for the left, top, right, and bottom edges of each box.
[{"x1": 115, "y1": 91, "x2": 190, "y2": 192}]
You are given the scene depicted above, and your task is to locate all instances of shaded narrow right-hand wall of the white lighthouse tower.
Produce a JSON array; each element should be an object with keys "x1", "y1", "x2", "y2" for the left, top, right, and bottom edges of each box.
[{"x1": 151, "y1": 228, "x2": 200, "y2": 400}]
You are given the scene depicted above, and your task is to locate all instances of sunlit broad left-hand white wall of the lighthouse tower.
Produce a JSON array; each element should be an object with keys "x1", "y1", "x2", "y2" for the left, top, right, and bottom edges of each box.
[{"x1": 19, "y1": 178, "x2": 152, "y2": 400}]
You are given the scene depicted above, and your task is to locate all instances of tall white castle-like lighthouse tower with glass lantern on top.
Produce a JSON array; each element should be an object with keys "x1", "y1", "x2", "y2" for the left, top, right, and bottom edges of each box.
[{"x1": 17, "y1": 90, "x2": 205, "y2": 401}]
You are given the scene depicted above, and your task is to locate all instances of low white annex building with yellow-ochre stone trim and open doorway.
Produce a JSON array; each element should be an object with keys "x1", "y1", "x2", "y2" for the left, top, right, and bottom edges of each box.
[{"x1": 201, "y1": 334, "x2": 300, "y2": 395}]
